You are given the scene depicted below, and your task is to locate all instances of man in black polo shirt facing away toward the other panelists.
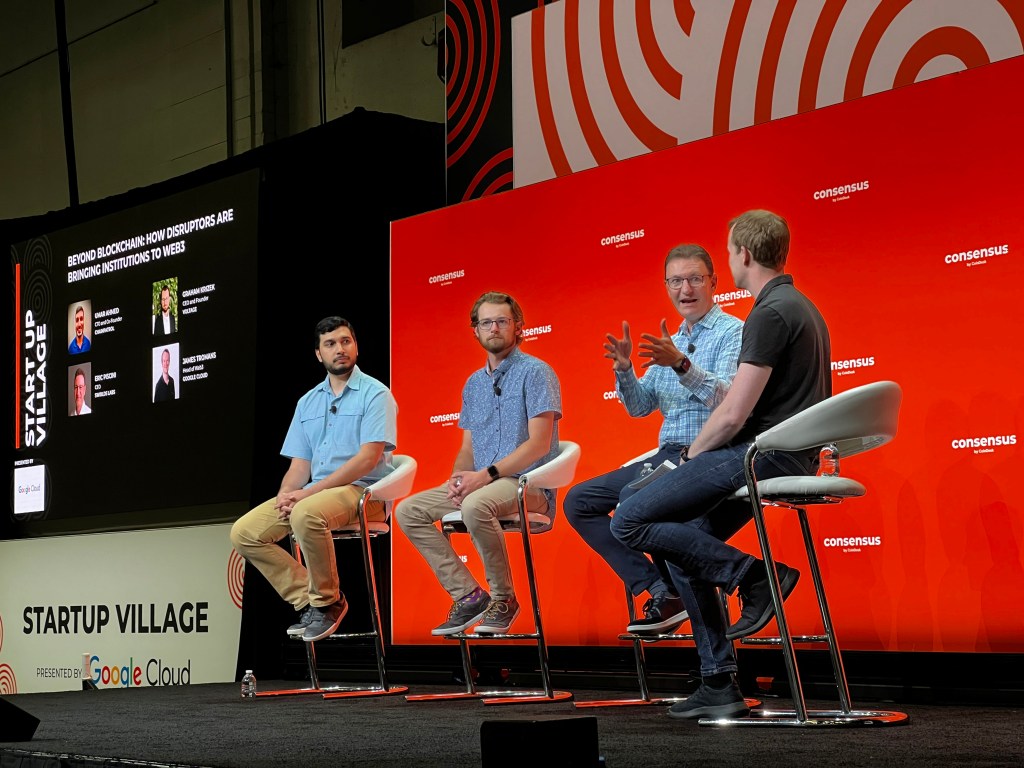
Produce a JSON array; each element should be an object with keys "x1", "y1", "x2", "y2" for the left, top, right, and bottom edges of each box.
[{"x1": 611, "y1": 211, "x2": 831, "y2": 719}]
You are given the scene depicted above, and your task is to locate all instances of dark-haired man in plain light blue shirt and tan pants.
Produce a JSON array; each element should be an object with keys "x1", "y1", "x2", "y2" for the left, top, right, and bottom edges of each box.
[{"x1": 231, "y1": 316, "x2": 398, "y2": 642}]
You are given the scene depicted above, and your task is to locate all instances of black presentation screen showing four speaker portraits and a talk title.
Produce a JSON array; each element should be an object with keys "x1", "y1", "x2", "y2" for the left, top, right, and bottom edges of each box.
[{"x1": 9, "y1": 172, "x2": 258, "y2": 535}]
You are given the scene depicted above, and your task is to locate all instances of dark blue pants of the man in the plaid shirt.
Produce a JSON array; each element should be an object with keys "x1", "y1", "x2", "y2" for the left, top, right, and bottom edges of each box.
[{"x1": 562, "y1": 445, "x2": 682, "y2": 595}]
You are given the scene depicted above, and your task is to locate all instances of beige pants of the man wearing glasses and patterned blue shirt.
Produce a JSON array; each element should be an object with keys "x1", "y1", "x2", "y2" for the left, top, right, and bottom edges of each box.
[{"x1": 394, "y1": 477, "x2": 548, "y2": 602}]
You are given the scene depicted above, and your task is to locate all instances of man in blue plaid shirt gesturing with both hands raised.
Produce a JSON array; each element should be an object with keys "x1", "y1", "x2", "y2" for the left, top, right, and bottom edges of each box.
[{"x1": 562, "y1": 245, "x2": 742, "y2": 634}]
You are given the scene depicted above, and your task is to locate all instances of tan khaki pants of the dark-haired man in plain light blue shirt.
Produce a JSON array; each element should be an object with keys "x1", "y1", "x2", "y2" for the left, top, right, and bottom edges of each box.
[{"x1": 231, "y1": 485, "x2": 386, "y2": 610}]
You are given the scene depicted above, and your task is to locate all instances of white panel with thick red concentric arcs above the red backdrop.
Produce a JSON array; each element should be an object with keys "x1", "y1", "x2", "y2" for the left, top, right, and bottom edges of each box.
[{"x1": 520, "y1": 0, "x2": 1024, "y2": 186}]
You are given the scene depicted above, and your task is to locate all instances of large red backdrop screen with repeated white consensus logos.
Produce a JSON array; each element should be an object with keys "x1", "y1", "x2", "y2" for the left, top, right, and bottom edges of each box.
[{"x1": 391, "y1": 57, "x2": 1024, "y2": 652}]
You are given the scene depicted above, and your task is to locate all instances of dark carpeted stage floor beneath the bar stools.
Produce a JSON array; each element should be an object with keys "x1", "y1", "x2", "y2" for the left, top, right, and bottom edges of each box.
[{"x1": 0, "y1": 681, "x2": 1024, "y2": 768}]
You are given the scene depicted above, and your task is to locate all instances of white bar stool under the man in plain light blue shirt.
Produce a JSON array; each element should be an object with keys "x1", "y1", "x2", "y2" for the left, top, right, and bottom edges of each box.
[{"x1": 256, "y1": 454, "x2": 417, "y2": 698}]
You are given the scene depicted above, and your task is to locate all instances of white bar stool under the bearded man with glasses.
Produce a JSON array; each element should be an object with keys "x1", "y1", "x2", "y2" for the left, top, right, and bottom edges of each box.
[{"x1": 406, "y1": 440, "x2": 580, "y2": 705}]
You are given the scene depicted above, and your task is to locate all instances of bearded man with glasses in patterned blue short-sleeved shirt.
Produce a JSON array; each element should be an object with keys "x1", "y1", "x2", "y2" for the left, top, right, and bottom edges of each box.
[{"x1": 394, "y1": 292, "x2": 562, "y2": 635}]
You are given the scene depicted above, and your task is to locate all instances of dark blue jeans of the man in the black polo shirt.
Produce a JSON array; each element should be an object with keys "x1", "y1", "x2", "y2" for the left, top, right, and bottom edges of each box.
[{"x1": 610, "y1": 443, "x2": 814, "y2": 677}]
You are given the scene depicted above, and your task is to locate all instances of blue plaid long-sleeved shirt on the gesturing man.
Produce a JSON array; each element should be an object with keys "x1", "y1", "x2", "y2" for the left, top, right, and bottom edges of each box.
[{"x1": 615, "y1": 304, "x2": 743, "y2": 446}]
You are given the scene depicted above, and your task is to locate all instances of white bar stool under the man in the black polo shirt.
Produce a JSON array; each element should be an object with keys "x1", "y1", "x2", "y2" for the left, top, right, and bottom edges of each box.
[{"x1": 697, "y1": 381, "x2": 908, "y2": 727}]
